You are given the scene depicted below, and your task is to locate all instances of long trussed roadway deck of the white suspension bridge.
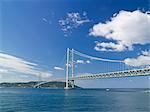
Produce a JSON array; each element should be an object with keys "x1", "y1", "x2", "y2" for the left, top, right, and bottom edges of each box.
[{"x1": 34, "y1": 68, "x2": 150, "y2": 87}]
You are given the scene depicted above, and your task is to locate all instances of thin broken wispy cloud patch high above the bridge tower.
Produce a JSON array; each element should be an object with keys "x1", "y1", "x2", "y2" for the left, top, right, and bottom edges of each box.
[{"x1": 58, "y1": 12, "x2": 90, "y2": 36}]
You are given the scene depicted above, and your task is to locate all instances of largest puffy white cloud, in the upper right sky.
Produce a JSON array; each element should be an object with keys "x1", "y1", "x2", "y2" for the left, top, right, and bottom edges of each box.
[{"x1": 90, "y1": 10, "x2": 150, "y2": 51}]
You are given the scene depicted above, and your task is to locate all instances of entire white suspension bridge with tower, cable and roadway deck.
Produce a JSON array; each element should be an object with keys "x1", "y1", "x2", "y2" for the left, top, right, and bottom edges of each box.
[{"x1": 34, "y1": 48, "x2": 150, "y2": 89}]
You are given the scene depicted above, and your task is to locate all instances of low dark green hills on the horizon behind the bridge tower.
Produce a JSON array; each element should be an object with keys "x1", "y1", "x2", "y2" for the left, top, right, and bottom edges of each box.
[{"x1": 0, "y1": 81, "x2": 80, "y2": 88}]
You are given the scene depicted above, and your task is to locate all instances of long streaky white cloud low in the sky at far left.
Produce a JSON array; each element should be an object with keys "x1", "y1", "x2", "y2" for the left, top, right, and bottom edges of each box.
[{"x1": 0, "y1": 53, "x2": 52, "y2": 78}]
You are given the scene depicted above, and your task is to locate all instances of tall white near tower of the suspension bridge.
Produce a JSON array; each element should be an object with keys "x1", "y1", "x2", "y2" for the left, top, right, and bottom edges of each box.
[{"x1": 65, "y1": 48, "x2": 74, "y2": 89}]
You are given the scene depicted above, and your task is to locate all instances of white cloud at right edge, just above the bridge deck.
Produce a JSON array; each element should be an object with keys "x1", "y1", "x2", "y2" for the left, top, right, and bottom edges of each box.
[{"x1": 124, "y1": 51, "x2": 150, "y2": 67}]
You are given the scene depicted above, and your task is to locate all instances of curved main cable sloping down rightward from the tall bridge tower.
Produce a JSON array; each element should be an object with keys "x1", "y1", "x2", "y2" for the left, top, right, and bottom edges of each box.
[{"x1": 74, "y1": 50, "x2": 124, "y2": 63}]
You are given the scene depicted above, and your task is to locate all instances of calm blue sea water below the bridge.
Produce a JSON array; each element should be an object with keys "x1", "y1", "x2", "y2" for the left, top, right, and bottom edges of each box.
[{"x1": 0, "y1": 88, "x2": 150, "y2": 112}]
